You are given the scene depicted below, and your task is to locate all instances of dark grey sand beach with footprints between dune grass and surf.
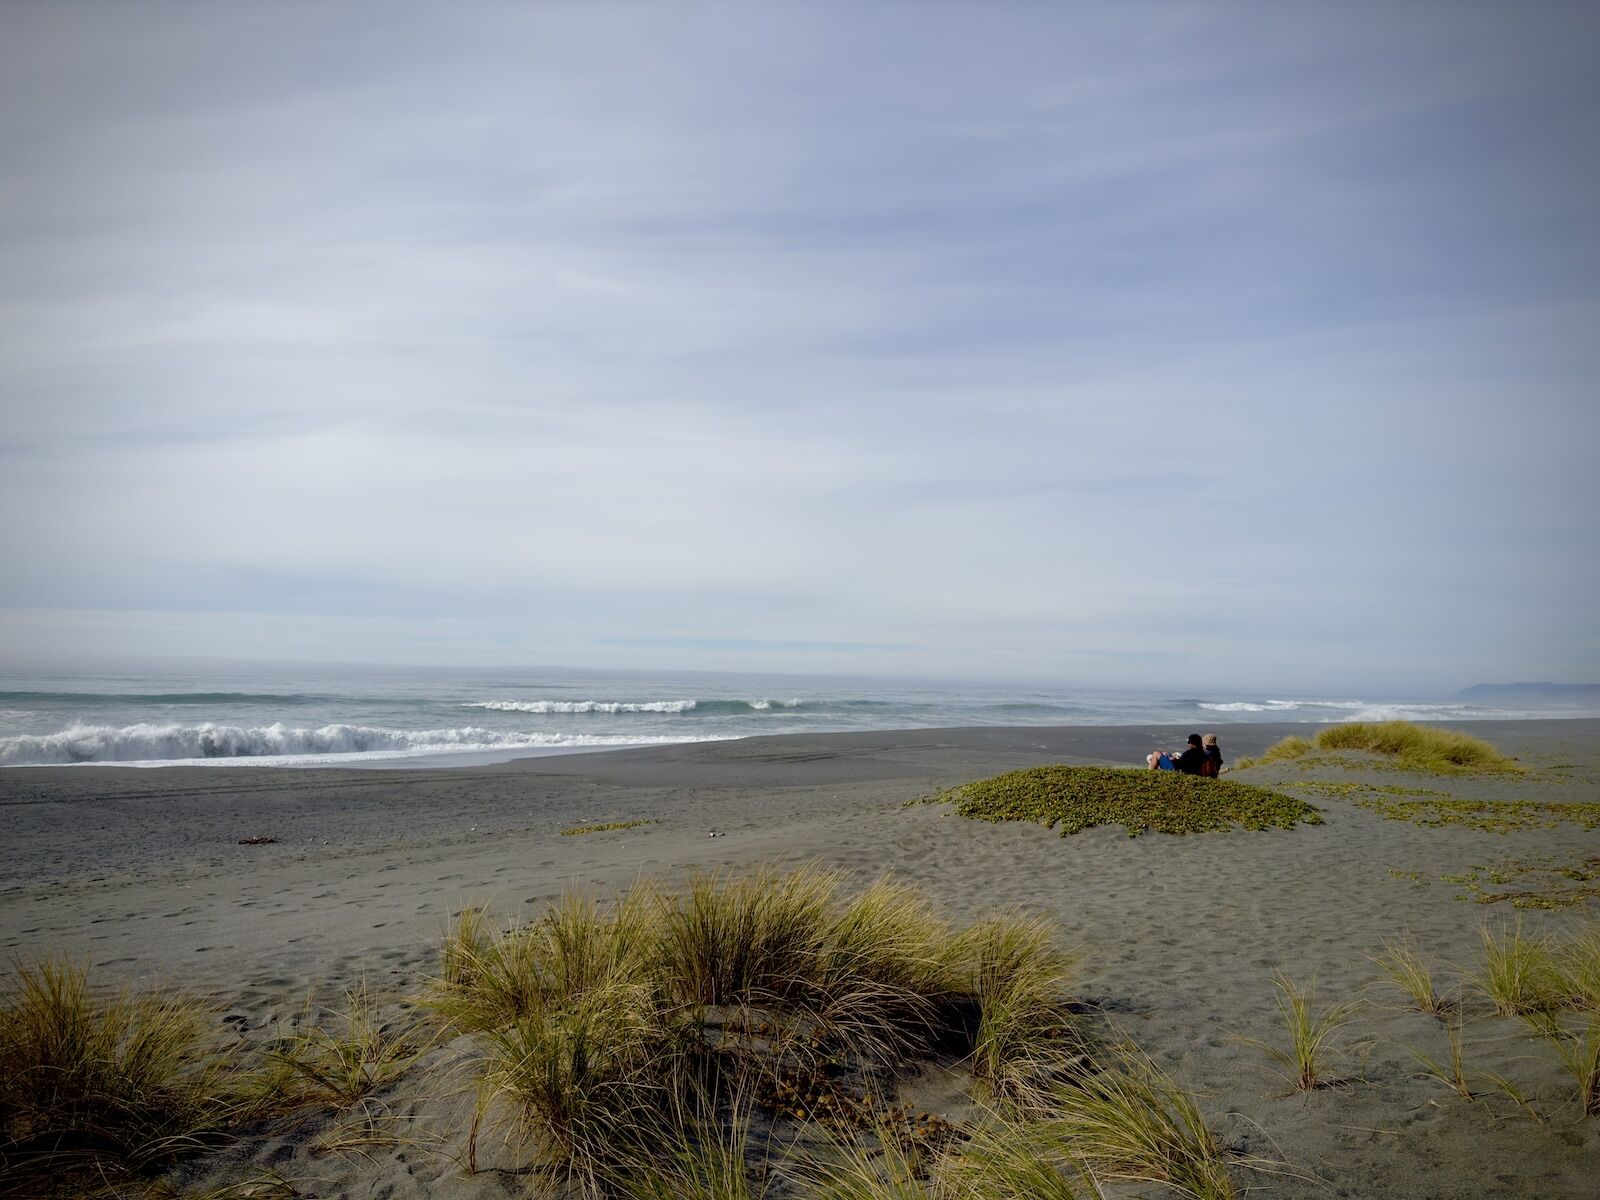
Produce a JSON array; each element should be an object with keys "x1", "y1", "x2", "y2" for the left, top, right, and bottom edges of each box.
[{"x1": 0, "y1": 720, "x2": 1600, "y2": 1197}]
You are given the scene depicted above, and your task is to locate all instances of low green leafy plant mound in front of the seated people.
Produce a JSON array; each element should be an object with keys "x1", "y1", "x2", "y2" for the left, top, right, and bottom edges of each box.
[{"x1": 941, "y1": 766, "x2": 1322, "y2": 837}]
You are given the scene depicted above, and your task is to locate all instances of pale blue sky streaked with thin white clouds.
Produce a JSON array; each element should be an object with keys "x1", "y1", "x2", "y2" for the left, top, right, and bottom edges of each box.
[{"x1": 0, "y1": 0, "x2": 1600, "y2": 693}]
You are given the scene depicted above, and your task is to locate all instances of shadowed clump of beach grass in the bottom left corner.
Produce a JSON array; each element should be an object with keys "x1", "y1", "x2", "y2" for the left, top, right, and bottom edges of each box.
[{"x1": 0, "y1": 958, "x2": 240, "y2": 1197}]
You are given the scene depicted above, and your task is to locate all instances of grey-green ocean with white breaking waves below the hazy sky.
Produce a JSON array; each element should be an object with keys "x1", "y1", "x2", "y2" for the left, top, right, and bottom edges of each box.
[{"x1": 0, "y1": 664, "x2": 1600, "y2": 766}]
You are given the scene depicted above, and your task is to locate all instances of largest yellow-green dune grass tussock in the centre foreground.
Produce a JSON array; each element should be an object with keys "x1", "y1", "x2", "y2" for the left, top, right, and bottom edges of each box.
[{"x1": 429, "y1": 867, "x2": 1113, "y2": 1195}]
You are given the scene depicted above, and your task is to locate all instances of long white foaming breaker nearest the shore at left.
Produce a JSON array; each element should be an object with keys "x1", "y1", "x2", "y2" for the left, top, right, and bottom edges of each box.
[{"x1": 0, "y1": 723, "x2": 723, "y2": 766}]
